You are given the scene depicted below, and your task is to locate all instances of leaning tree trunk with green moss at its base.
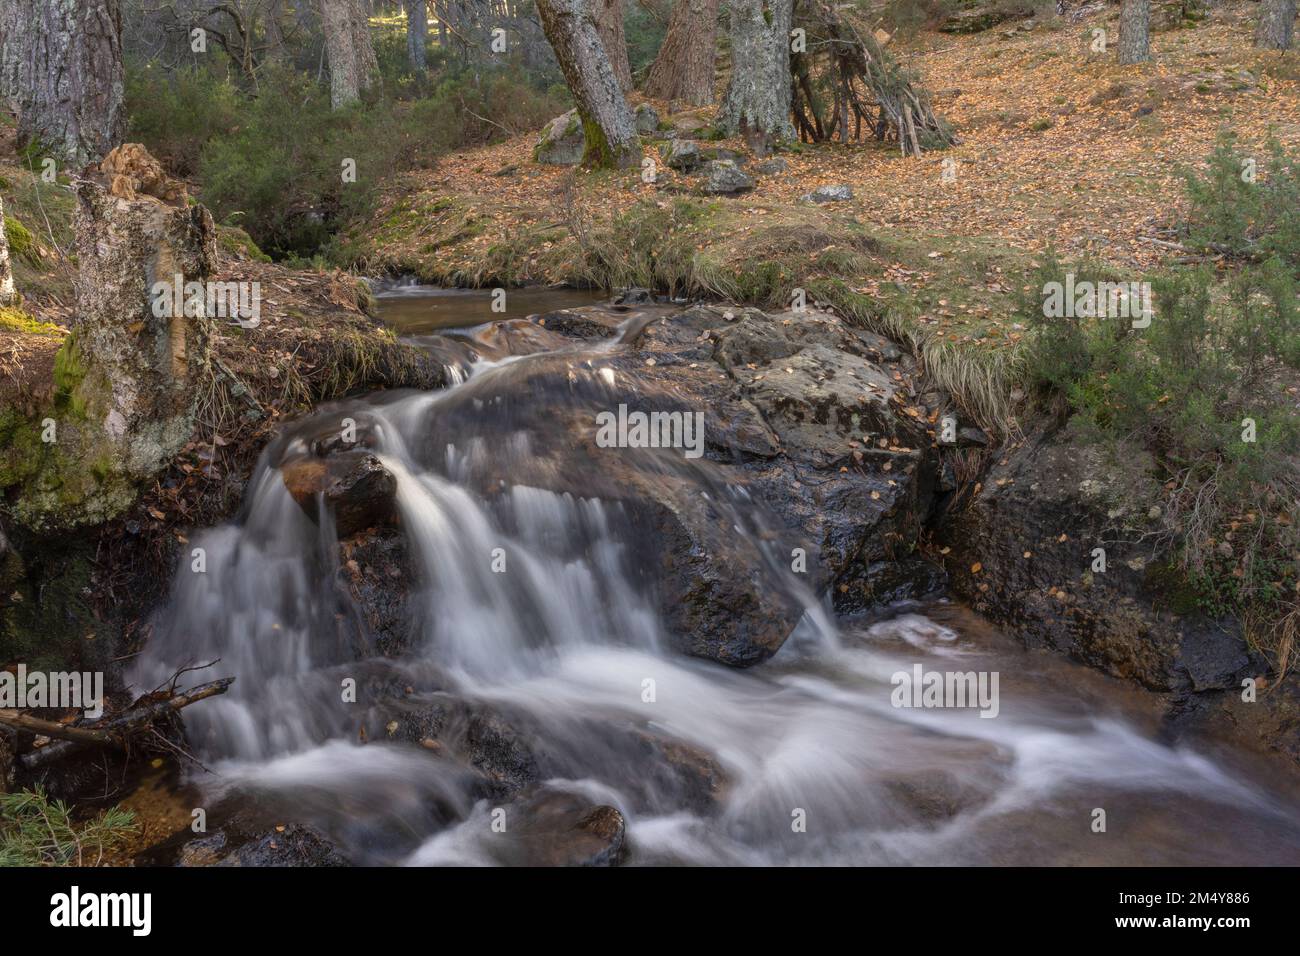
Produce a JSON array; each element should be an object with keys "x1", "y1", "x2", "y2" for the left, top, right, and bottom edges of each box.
[{"x1": 537, "y1": 0, "x2": 641, "y2": 166}]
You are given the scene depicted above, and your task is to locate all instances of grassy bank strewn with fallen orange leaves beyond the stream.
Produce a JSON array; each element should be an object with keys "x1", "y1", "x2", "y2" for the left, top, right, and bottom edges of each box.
[{"x1": 348, "y1": 4, "x2": 1300, "y2": 432}]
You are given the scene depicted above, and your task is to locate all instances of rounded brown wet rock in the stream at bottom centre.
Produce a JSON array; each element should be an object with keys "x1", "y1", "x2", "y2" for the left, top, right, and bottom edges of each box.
[{"x1": 497, "y1": 790, "x2": 627, "y2": 866}]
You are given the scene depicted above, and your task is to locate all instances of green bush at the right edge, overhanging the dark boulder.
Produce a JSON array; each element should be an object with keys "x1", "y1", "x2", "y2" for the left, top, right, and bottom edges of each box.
[{"x1": 1021, "y1": 144, "x2": 1300, "y2": 659}]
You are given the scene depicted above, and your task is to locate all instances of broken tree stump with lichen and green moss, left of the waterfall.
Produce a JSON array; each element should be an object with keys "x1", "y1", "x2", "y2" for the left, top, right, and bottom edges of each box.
[{"x1": 0, "y1": 147, "x2": 216, "y2": 529}]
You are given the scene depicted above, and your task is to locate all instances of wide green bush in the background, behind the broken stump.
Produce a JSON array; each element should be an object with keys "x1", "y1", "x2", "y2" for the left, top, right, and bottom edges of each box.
[{"x1": 129, "y1": 61, "x2": 567, "y2": 259}]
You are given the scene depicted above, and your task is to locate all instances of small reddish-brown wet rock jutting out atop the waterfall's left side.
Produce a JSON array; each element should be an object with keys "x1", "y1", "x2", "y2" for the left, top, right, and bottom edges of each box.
[{"x1": 281, "y1": 450, "x2": 397, "y2": 537}]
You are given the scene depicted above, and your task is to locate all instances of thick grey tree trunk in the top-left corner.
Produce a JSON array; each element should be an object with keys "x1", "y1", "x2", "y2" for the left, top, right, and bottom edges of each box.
[{"x1": 0, "y1": 0, "x2": 126, "y2": 169}]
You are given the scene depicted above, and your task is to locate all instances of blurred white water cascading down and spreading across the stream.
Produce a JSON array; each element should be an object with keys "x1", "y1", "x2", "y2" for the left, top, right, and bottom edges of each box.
[{"x1": 134, "y1": 297, "x2": 1300, "y2": 865}]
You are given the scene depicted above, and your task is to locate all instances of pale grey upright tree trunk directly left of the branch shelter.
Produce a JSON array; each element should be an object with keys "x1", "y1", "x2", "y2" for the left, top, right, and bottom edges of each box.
[{"x1": 718, "y1": 0, "x2": 794, "y2": 156}]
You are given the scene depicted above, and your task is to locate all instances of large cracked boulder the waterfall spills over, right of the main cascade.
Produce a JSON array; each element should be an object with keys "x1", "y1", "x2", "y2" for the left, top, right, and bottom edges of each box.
[{"x1": 413, "y1": 306, "x2": 937, "y2": 666}]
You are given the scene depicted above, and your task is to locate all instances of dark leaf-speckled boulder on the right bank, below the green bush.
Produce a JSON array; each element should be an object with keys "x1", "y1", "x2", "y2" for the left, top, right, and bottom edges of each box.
[{"x1": 939, "y1": 425, "x2": 1264, "y2": 693}]
